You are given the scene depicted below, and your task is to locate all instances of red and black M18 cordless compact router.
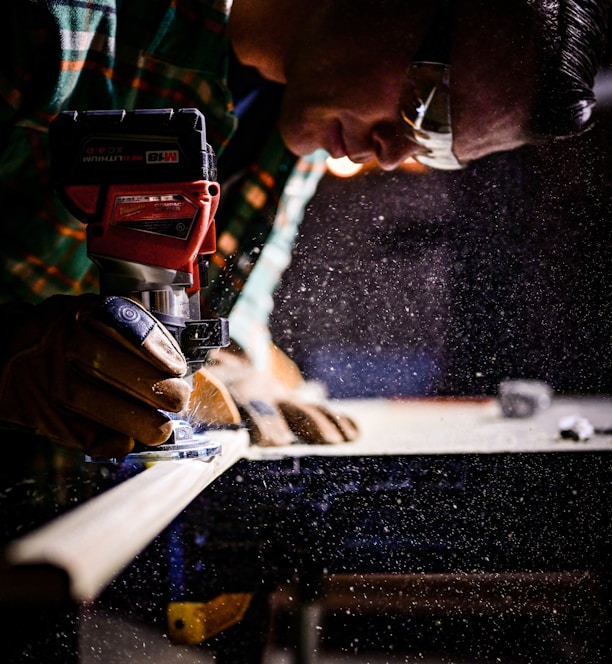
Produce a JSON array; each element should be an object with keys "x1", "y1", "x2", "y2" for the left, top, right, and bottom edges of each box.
[{"x1": 49, "y1": 108, "x2": 229, "y2": 458}]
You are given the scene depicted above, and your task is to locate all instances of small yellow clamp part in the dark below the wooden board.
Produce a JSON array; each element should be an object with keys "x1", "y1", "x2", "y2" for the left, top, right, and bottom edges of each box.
[{"x1": 166, "y1": 593, "x2": 253, "y2": 645}]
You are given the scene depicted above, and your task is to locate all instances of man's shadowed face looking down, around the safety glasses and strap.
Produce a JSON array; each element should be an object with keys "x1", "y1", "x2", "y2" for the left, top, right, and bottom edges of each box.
[{"x1": 280, "y1": 0, "x2": 541, "y2": 169}]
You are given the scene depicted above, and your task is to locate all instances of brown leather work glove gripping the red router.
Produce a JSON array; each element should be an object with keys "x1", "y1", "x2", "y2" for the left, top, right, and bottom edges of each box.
[{"x1": 0, "y1": 295, "x2": 190, "y2": 458}]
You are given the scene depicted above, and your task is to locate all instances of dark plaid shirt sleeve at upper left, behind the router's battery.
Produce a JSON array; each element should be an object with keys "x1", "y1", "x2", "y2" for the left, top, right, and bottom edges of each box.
[{"x1": 0, "y1": 0, "x2": 235, "y2": 302}]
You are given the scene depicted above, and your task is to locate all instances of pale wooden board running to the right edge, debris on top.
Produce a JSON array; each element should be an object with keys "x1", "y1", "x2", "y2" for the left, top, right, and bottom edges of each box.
[{"x1": 248, "y1": 397, "x2": 612, "y2": 460}]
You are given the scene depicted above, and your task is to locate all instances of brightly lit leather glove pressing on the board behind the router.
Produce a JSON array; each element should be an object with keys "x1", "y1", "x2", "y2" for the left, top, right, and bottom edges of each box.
[{"x1": 189, "y1": 345, "x2": 358, "y2": 446}]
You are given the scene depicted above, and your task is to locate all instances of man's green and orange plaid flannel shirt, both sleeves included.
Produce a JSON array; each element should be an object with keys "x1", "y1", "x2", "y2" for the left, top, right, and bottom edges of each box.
[{"x1": 0, "y1": 0, "x2": 323, "y2": 364}]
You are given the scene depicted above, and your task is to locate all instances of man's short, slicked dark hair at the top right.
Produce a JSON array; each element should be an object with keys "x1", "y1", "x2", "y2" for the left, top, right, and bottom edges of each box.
[{"x1": 531, "y1": 0, "x2": 610, "y2": 138}]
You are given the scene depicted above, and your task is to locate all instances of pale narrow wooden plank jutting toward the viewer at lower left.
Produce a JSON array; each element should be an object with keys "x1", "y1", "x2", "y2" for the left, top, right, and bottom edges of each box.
[{"x1": 6, "y1": 430, "x2": 249, "y2": 602}]
